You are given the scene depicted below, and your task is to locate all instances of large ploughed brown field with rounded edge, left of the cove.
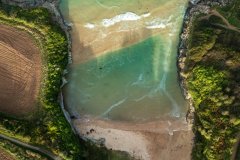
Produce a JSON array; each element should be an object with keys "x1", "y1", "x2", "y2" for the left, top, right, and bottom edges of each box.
[{"x1": 0, "y1": 24, "x2": 41, "y2": 116}]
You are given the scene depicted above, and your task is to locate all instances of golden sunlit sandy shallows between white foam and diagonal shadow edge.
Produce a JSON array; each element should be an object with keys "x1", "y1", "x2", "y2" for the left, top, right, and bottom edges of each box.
[{"x1": 71, "y1": 21, "x2": 171, "y2": 64}]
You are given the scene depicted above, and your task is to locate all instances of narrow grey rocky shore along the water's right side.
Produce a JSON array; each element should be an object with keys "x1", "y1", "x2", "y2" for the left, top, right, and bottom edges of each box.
[{"x1": 177, "y1": 0, "x2": 231, "y2": 125}]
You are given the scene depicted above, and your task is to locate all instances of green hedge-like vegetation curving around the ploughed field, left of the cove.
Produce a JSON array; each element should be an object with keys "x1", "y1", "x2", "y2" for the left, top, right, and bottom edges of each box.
[{"x1": 0, "y1": 1, "x2": 132, "y2": 160}]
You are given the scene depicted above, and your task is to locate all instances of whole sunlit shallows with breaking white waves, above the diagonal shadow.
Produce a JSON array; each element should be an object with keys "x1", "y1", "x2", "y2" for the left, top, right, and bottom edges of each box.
[{"x1": 61, "y1": 0, "x2": 188, "y2": 64}]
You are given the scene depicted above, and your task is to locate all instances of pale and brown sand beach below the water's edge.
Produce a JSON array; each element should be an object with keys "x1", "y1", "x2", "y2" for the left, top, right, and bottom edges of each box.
[{"x1": 74, "y1": 119, "x2": 193, "y2": 160}]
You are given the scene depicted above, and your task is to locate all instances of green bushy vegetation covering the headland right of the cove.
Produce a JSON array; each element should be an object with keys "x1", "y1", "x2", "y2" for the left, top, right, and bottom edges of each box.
[{"x1": 185, "y1": 0, "x2": 240, "y2": 160}]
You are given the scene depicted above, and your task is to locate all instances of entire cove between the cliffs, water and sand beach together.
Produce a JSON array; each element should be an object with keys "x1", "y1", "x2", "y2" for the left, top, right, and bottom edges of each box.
[{"x1": 60, "y1": 0, "x2": 192, "y2": 159}]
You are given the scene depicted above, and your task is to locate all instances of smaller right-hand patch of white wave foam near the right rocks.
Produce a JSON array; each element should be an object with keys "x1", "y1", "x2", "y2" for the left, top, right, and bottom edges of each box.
[{"x1": 146, "y1": 16, "x2": 172, "y2": 29}]
